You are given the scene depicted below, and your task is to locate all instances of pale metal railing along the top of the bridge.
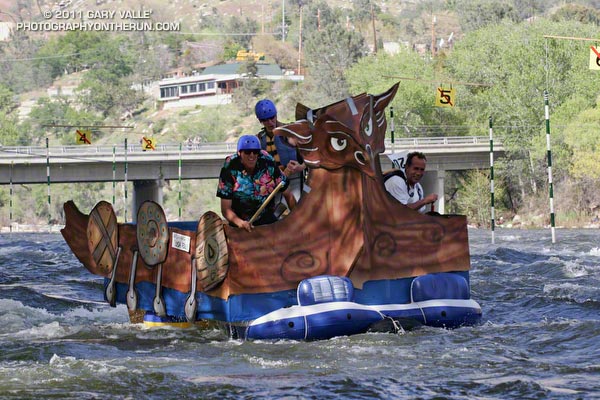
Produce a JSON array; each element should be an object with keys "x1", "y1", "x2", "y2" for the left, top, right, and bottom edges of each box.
[{"x1": 0, "y1": 136, "x2": 500, "y2": 158}]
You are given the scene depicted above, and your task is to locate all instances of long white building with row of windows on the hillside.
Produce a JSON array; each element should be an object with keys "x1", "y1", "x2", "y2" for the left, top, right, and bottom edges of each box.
[{"x1": 158, "y1": 62, "x2": 304, "y2": 108}]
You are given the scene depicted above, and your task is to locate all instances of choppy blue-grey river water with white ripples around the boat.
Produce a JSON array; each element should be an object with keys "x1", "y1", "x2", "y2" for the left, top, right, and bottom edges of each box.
[{"x1": 0, "y1": 229, "x2": 600, "y2": 399}]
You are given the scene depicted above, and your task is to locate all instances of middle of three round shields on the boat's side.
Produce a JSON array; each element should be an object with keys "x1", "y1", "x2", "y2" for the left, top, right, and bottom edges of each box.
[{"x1": 136, "y1": 200, "x2": 169, "y2": 267}]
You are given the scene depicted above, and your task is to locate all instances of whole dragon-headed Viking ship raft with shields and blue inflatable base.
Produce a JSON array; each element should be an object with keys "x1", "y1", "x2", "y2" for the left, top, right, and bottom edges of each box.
[{"x1": 61, "y1": 84, "x2": 481, "y2": 339}]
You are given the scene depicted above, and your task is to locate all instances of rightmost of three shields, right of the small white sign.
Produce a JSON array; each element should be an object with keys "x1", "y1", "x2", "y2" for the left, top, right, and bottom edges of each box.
[{"x1": 195, "y1": 211, "x2": 229, "y2": 291}]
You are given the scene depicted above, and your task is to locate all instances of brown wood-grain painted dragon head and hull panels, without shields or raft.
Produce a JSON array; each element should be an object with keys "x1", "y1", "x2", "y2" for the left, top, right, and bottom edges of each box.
[{"x1": 61, "y1": 84, "x2": 470, "y2": 299}]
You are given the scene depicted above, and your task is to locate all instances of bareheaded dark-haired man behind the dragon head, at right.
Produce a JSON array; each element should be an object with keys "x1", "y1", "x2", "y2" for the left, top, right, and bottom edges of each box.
[{"x1": 383, "y1": 151, "x2": 438, "y2": 214}]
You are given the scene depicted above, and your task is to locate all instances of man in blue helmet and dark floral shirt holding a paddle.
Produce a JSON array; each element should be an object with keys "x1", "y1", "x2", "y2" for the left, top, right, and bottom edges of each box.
[{"x1": 217, "y1": 135, "x2": 296, "y2": 232}]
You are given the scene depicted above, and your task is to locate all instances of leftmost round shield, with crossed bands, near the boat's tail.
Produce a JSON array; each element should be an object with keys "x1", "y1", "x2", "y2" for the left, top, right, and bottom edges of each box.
[{"x1": 86, "y1": 201, "x2": 119, "y2": 276}]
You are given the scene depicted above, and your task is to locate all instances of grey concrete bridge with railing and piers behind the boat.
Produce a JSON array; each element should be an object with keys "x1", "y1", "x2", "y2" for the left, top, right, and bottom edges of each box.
[{"x1": 0, "y1": 136, "x2": 504, "y2": 219}]
